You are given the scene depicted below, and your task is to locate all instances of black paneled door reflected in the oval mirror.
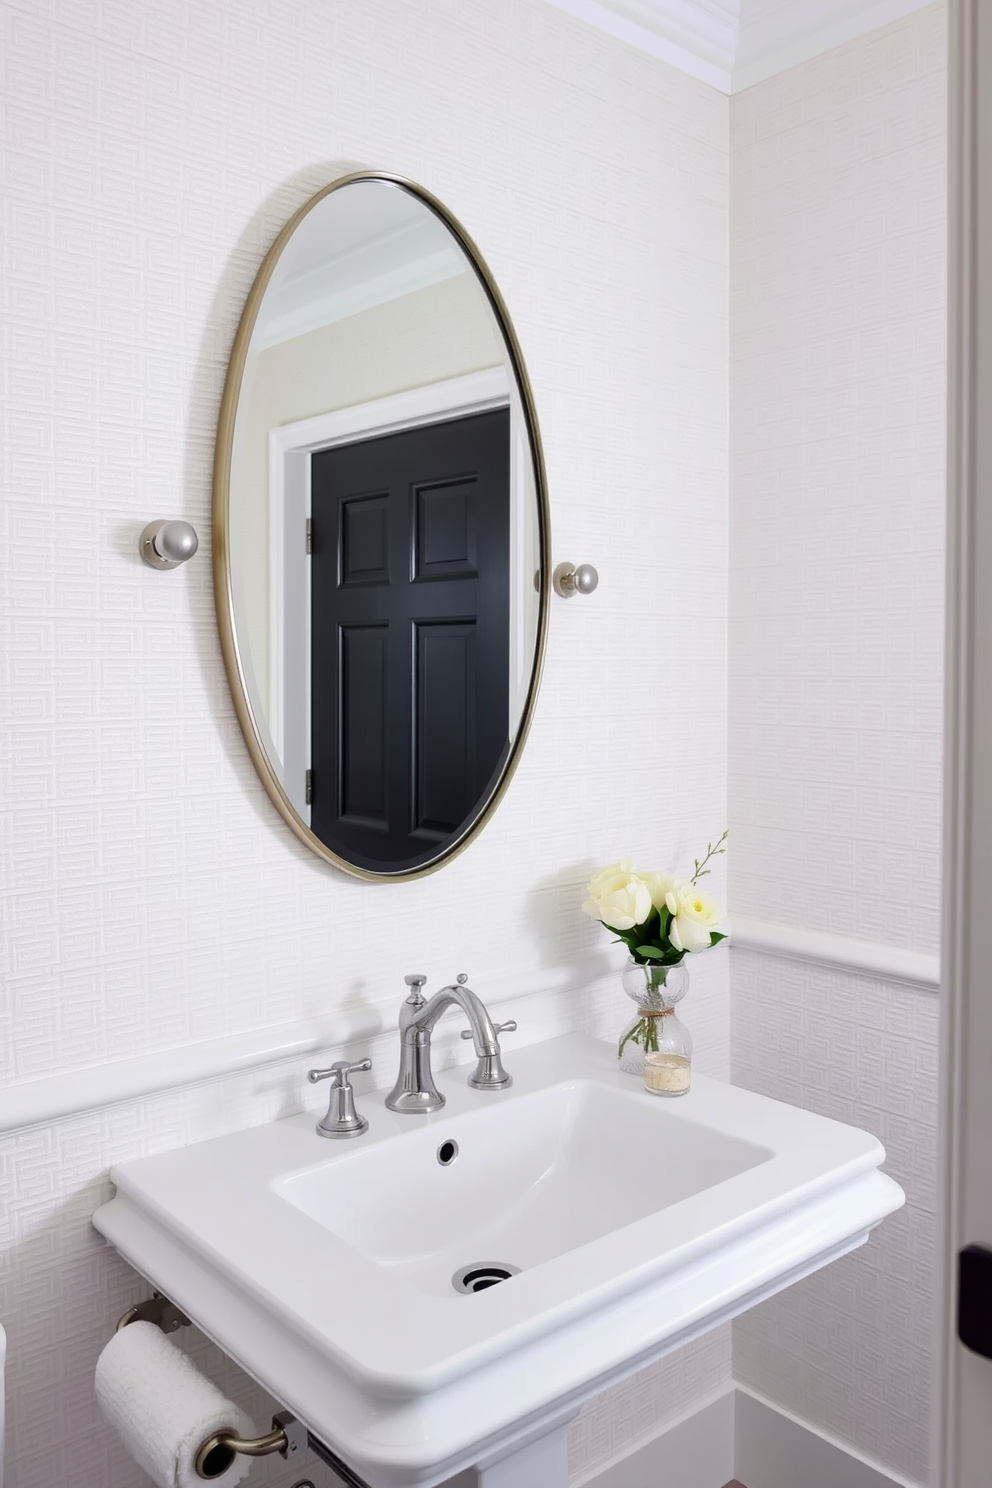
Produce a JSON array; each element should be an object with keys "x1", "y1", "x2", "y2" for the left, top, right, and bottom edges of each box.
[{"x1": 311, "y1": 409, "x2": 510, "y2": 872}]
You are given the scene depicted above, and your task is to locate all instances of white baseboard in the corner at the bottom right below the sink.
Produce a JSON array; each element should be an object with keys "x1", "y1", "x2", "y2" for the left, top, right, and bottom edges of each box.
[{"x1": 583, "y1": 1385, "x2": 924, "y2": 1488}]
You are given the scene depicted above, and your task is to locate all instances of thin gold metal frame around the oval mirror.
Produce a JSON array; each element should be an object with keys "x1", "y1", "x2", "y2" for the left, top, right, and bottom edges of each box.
[{"x1": 213, "y1": 171, "x2": 552, "y2": 882}]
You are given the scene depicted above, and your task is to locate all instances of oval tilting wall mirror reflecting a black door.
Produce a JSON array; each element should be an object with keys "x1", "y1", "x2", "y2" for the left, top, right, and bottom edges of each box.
[{"x1": 214, "y1": 173, "x2": 549, "y2": 879}]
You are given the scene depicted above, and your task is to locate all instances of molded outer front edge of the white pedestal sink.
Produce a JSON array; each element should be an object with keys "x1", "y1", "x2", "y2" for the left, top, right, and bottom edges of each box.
[{"x1": 89, "y1": 1171, "x2": 904, "y2": 1488}]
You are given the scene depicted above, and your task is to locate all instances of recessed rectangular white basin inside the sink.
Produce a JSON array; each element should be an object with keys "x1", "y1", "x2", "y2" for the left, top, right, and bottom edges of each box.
[{"x1": 274, "y1": 1079, "x2": 775, "y2": 1303}]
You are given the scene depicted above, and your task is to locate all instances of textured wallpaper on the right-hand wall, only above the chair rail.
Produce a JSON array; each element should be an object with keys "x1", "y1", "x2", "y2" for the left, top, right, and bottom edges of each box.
[{"x1": 730, "y1": 6, "x2": 946, "y2": 951}]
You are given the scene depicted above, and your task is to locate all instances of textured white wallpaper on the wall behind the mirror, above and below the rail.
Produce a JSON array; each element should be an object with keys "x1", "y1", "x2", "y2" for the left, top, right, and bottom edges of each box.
[{"x1": 0, "y1": 0, "x2": 729, "y2": 1488}]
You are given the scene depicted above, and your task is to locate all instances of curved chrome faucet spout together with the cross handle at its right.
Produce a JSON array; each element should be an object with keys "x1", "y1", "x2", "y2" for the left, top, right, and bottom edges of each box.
[{"x1": 385, "y1": 972, "x2": 516, "y2": 1112}]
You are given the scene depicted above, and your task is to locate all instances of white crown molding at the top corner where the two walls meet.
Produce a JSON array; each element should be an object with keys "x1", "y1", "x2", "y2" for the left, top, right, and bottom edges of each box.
[{"x1": 549, "y1": 0, "x2": 931, "y2": 92}]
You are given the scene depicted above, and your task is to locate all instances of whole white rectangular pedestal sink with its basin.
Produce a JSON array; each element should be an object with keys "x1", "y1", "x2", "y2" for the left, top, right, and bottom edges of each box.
[{"x1": 94, "y1": 1034, "x2": 903, "y2": 1488}]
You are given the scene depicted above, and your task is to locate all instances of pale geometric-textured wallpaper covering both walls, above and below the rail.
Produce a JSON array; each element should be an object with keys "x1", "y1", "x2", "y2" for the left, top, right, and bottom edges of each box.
[{"x1": 0, "y1": 0, "x2": 944, "y2": 1488}]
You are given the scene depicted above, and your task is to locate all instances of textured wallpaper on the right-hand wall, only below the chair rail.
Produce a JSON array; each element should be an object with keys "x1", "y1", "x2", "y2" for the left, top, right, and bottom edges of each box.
[{"x1": 732, "y1": 952, "x2": 937, "y2": 1482}]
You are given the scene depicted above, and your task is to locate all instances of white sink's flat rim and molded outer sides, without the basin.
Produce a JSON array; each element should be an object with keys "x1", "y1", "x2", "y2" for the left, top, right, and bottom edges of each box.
[{"x1": 94, "y1": 1034, "x2": 904, "y2": 1485}]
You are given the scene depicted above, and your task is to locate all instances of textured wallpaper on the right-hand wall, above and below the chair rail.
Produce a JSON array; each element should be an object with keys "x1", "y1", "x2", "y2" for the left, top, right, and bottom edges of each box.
[{"x1": 729, "y1": 4, "x2": 946, "y2": 1481}]
